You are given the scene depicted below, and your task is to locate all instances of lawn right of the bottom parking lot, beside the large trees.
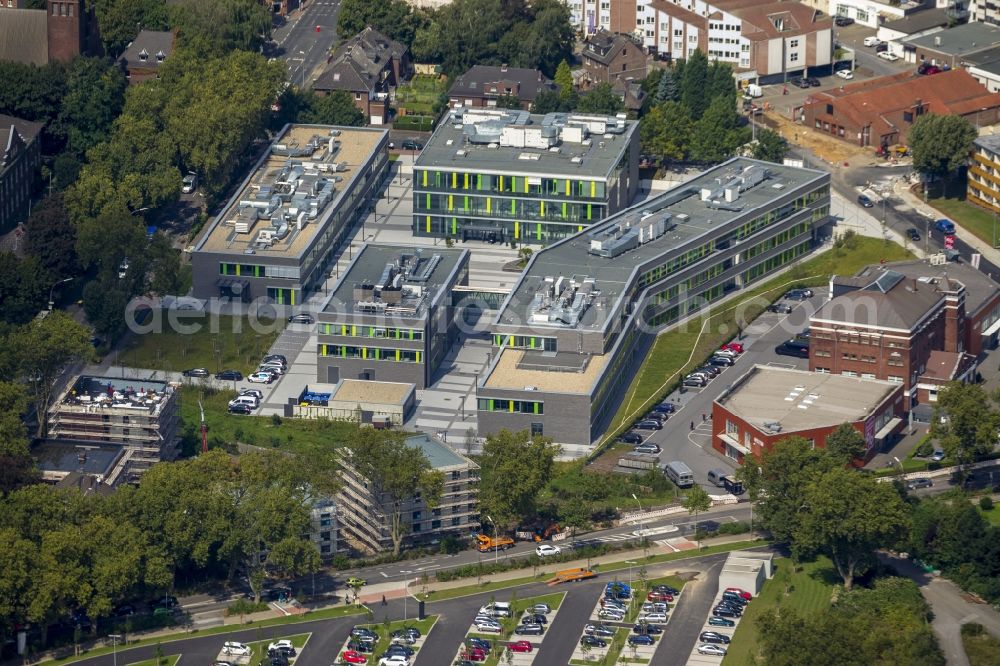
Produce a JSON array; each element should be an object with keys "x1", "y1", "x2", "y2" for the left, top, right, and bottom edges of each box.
[{"x1": 722, "y1": 558, "x2": 840, "y2": 666}]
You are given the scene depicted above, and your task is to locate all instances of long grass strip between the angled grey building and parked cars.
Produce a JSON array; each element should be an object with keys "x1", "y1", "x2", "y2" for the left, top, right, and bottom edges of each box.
[{"x1": 591, "y1": 236, "x2": 913, "y2": 448}]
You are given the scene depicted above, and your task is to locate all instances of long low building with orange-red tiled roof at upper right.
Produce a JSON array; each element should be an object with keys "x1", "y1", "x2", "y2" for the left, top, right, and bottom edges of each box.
[{"x1": 801, "y1": 69, "x2": 1000, "y2": 147}]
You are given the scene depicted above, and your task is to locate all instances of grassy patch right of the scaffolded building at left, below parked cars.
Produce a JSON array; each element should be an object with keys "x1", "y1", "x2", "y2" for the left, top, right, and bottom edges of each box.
[{"x1": 180, "y1": 385, "x2": 357, "y2": 454}]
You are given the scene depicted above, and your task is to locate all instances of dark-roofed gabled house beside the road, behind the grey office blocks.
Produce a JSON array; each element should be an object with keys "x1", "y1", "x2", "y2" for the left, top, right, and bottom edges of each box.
[{"x1": 312, "y1": 26, "x2": 412, "y2": 125}]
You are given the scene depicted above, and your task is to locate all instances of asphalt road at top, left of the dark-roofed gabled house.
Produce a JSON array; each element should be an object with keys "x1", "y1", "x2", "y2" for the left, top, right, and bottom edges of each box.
[{"x1": 272, "y1": 0, "x2": 340, "y2": 88}]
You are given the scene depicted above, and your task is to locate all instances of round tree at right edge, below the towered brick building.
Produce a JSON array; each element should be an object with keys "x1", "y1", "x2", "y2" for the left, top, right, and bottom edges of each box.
[{"x1": 930, "y1": 382, "x2": 1000, "y2": 465}]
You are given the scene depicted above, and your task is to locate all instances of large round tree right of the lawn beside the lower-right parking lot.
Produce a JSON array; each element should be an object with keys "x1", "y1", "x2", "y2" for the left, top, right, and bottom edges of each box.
[{"x1": 792, "y1": 467, "x2": 909, "y2": 590}]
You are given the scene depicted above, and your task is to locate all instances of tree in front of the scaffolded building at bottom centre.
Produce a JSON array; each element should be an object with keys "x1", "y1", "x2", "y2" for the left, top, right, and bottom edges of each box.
[{"x1": 348, "y1": 428, "x2": 444, "y2": 555}]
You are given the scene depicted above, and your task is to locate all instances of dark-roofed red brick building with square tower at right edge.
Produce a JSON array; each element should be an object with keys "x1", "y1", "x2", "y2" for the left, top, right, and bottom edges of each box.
[{"x1": 809, "y1": 260, "x2": 1000, "y2": 409}]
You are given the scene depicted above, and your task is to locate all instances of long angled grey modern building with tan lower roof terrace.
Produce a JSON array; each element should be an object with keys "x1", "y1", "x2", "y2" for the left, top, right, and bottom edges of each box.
[{"x1": 477, "y1": 158, "x2": 830, "y2": 446}]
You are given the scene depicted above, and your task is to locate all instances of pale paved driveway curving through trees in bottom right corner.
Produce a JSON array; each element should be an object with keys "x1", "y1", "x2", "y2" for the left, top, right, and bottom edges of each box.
[{"x1": 878, "y1": 553, "x2": 1000, "y2": 666}]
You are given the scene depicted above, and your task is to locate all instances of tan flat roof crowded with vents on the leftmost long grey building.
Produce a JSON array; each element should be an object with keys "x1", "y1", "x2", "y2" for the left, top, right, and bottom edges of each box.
[{"x1": 195, "y1": 125, "x2": 388, "y2": 264}]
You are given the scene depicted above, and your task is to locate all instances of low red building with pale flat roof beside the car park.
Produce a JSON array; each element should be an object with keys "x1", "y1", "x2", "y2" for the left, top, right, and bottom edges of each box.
[{"x1": 712, "y1": 365, "x2": 903, "y2": 463}]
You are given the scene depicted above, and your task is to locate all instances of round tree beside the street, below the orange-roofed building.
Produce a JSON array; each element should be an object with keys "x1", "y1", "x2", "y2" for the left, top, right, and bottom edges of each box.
[{"x1": 909, "y1": 113, "x2": 977, "y2": 182}]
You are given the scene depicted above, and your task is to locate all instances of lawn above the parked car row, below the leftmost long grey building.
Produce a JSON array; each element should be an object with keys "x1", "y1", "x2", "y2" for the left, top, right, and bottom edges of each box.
[{"x1": 122, "y1": 313, "x2": 284, "y2": 375}]
